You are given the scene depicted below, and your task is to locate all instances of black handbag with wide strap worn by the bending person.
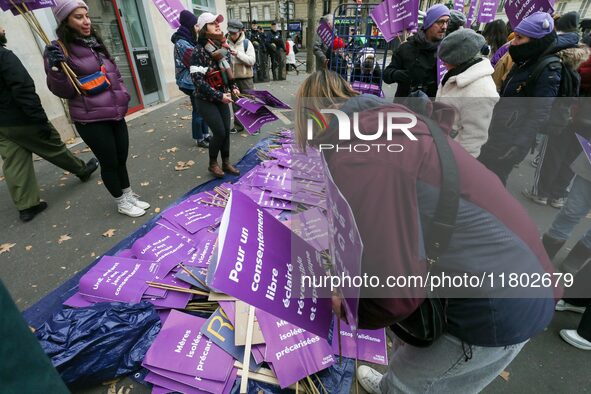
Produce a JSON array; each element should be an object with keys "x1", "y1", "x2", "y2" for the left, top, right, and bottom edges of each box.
[{"x1": 390, "y1": 115, "x2": 460, "y2": 347}]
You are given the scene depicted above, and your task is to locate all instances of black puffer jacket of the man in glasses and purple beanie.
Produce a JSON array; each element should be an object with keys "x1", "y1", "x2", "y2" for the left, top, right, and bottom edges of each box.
[{"x1": 384, "y1": 30, "x2": 439, "y2": 97}]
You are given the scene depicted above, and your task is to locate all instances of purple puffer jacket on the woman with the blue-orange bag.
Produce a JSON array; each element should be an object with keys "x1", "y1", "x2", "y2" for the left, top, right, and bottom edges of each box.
[{"x1": 44, "y1": 38, "x2": 130, "y2": 123}]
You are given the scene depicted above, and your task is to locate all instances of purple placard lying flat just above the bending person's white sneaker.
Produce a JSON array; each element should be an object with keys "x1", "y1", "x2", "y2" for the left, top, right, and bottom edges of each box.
[{"x1": 332, "y1": 319, "x2": 388, "y2": 365}]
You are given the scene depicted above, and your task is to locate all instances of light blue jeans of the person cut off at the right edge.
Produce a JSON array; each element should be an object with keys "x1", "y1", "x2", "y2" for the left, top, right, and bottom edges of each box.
[{"x1": 548, "y1": 175, "x2": 591, "y2": 249}]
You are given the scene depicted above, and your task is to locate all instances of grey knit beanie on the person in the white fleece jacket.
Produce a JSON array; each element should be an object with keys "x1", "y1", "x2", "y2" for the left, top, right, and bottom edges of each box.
[{"x1": 437, "y1": 29, "x2": 486, "y2": 66}]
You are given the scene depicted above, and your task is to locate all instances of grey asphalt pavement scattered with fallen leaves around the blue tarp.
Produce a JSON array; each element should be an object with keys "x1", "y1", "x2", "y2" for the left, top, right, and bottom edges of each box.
[{"x1": 0, "y1": 73, "x2": 591, "y2": 394}]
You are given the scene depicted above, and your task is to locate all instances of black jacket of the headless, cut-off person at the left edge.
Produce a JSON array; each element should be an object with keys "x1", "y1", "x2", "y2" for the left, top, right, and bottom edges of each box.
[{"x1": 0, "y1": 46, "x2": 47, "y2": 126}]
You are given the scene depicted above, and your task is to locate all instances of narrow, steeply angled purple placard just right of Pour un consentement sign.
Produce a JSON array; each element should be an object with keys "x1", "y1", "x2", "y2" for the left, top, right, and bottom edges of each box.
[{"x1": 322, "y1": 156, "x2": 363, "y2": 328}]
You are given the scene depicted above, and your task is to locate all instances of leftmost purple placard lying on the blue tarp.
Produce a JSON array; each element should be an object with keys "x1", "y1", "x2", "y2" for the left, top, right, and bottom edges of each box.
[{"x1": 79, "y1": 256, "x2": 159, "y2": 303}]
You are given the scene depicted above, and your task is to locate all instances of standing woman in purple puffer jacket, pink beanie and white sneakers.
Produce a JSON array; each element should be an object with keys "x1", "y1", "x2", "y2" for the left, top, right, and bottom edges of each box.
[{"x1": 44, "y1": 0, "x2": 150, "y2": 217}]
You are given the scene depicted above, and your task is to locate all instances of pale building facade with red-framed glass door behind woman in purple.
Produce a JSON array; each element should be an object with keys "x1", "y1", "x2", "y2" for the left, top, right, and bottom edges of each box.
[{"x1": 0, "y1": 0, "x2": 226, "y2": 140}]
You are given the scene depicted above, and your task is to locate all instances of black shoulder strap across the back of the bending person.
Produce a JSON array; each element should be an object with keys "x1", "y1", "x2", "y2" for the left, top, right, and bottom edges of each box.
[{"x1": 417, "y1": 115, "x2": 460, "y2": 268}]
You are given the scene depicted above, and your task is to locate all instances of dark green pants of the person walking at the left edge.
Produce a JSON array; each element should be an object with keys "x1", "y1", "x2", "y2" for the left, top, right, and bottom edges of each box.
[{"x1": 0, "y1": 124, "x2": 86, "y2": 211}]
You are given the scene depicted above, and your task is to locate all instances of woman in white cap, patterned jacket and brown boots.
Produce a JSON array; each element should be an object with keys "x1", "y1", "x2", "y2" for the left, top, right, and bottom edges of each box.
[{"x1": 190, "y1": 12, "x2": 240, "y2": 178}]
